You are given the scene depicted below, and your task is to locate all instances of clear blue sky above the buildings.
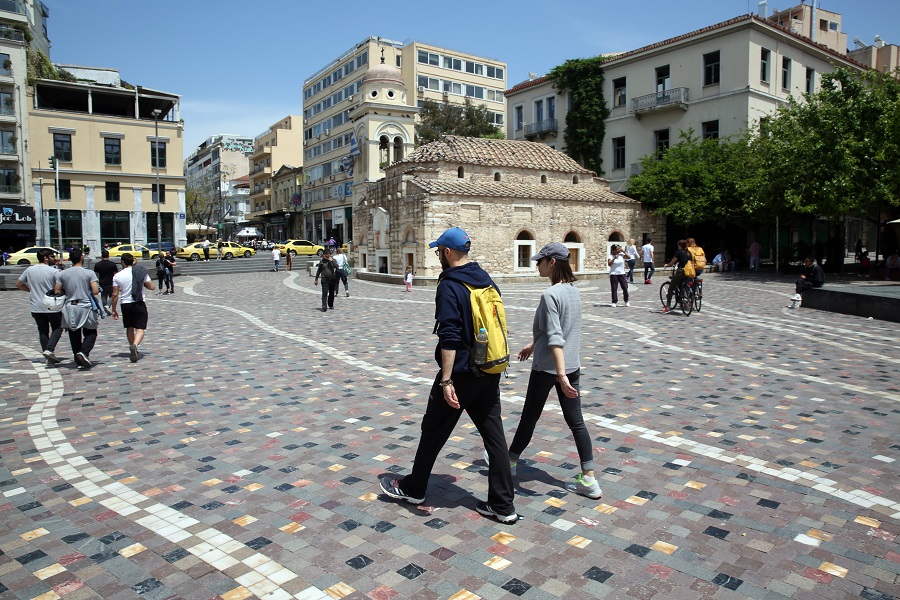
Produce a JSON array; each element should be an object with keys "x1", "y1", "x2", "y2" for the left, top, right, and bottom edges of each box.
[{"x1": 44, "y1": 0, "x2": 900, "y2": 155}]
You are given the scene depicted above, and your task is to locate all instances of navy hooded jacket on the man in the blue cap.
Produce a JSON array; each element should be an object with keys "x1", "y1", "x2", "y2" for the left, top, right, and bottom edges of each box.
[{"x1": 434, "y1": 262, "x2": 500, "y2": 373}]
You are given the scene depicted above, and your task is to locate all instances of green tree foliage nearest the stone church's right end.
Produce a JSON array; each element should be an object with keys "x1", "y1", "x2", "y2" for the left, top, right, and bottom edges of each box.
[{"x1": 628, "y1": 129, "x2": 754, "y2": 226}]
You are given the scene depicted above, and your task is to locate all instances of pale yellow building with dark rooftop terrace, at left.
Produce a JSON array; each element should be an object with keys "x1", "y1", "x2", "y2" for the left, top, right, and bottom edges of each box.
[{"x1": 27, "y1": 65, "x2": 187, "y2": 254}]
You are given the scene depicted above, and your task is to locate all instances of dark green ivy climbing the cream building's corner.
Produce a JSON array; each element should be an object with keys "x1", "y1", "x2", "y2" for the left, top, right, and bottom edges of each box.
[{"x1": 547, "y1": 56, "x2": 609, "y2": 175}]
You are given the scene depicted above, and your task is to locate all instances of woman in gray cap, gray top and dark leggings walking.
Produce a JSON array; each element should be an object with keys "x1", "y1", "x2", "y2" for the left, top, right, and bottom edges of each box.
[{"x1": 496, "y1": 242, "x2": 602, "y2": 498}]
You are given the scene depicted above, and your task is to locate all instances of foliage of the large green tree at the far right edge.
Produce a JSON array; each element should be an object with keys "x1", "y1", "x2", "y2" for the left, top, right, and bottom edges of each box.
[{"x1": 753, "y1": 69, "x2": 900, "y2": 217}]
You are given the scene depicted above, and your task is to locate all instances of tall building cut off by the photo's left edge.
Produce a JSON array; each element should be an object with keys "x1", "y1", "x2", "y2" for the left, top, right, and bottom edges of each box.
[{"x1": 0, "y1": 0, "x2": 50, "y2": 249}]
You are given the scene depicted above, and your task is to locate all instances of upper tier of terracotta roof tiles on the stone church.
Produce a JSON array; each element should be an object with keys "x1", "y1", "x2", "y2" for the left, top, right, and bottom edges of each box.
[{"x1": 391, "y1": 135, "x2": 593, "y2": 173}]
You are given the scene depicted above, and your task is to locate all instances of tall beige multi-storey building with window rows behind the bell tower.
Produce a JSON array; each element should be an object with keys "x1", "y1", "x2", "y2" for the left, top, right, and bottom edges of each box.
[{"x1": 303, "y1": 36, "x2": 506, "y2": 246}]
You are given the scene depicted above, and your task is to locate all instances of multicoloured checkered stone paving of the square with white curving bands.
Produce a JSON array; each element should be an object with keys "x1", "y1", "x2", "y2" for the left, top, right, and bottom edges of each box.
[{"x1": 0, "y1": 271, "x2": 900, "y2": 600}]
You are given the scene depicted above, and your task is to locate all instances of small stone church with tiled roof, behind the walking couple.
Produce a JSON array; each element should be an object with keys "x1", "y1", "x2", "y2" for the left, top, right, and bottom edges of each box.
[{"x1": 354, "y1": 136, "x2": 665, "y2": 278}]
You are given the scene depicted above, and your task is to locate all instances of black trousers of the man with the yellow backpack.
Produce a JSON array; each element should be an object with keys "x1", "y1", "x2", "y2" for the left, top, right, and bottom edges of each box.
[{"x1": 400, "y1": 372, "x2": 515, "y2": 514}]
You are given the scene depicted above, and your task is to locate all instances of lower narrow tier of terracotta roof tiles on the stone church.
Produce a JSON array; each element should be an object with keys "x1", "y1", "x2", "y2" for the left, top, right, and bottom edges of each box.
[{"x1": 410, "y1": 178, "x2": 638, "y2": 204}]
